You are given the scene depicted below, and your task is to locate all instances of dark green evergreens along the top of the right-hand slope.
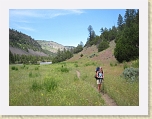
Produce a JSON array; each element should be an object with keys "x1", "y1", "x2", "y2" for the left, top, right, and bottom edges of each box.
[{"x1": 85, "y1": 9, "x2": 139, "y2": 62}]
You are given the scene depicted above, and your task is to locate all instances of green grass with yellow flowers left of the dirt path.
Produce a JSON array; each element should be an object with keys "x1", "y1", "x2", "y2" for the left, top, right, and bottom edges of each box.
[{"x1": 9, "y1": 63, "x2": 105, "y2": 106}]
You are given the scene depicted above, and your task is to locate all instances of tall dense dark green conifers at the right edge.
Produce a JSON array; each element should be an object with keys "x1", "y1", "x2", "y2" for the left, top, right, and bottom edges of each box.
[{"x1": 114, "y1": 9, "x2": 139, "y2": 62}]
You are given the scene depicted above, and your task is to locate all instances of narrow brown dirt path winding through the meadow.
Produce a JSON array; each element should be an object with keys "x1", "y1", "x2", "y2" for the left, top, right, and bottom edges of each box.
[{"x1": 76, "y1": 71, "x2": 117, "y2": 106}]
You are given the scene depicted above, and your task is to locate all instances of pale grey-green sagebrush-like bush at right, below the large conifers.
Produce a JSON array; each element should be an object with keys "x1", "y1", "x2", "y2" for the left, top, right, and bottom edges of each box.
[{"x1": 122, "y1": 67, "x2": 139, "y2": 81}]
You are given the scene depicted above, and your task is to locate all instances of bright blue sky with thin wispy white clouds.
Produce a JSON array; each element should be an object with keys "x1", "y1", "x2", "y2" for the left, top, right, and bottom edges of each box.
[{"x1": 9, "y1": 9, "x2": 126, "y2": 46}]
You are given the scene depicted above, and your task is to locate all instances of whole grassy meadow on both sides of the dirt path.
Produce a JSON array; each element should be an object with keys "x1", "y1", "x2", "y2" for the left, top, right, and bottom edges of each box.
[{"x1": 9, "y1": 58, "x2": 139, "y2": 106}]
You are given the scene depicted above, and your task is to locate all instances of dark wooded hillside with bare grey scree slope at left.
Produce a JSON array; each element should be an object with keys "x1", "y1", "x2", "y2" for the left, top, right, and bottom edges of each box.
[{"x1": 9, "y1": 29, "x2": 51, "y2": 56}]
